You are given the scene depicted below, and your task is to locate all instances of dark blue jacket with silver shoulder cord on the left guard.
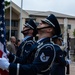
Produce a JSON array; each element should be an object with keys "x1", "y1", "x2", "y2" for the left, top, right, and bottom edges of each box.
[{"x1": 8, "y1": 37, "x2": 35, "y2": 64}]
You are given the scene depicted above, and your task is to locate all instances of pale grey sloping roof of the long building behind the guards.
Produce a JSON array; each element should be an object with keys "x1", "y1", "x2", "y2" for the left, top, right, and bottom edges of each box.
[{"x1": 25, "y1": 10, "x2": 75, "y2": 18}]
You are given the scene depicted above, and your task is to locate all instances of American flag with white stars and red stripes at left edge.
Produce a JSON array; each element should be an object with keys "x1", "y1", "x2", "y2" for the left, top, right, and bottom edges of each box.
[{"x1": 0, "y1": 0, "x2": 8, "y2": 75}]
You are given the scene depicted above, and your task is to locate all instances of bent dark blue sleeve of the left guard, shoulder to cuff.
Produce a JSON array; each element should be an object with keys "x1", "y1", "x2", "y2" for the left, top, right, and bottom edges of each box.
[{"x1": 9, "y1": 42, "x2": 33, "y2": 64}]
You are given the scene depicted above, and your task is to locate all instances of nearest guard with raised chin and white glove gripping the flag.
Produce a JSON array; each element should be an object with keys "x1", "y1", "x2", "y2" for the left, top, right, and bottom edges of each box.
[{"x1": 0, "y1": 14, "x2": 61, "y2": 75}]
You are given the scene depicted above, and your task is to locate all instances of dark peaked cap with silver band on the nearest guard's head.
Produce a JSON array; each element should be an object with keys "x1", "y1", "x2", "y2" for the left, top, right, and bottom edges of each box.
[{"x1": 41, "y1": 14, "x2": 61, "y2": 35}]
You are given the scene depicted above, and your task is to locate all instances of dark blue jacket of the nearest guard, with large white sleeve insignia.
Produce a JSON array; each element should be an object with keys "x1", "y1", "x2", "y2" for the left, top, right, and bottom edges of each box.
[{"x1": 9, "y1": 38, "x2": 55, "y2": 75}]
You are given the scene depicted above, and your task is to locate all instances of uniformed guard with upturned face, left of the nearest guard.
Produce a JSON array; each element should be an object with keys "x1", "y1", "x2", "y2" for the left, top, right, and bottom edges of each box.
[{"x1": 8, "y1": 19, "x2": 37, "y2": 64}]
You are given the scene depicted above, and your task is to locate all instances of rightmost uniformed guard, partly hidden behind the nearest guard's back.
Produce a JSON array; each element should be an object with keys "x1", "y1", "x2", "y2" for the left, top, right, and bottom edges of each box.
[{"x1": 51, "y1": 34, "x2": 70, "y2": 75}]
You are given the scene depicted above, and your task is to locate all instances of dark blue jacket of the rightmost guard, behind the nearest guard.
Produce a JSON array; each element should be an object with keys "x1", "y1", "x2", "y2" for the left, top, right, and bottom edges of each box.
[{"x1": 51, "y1": 44, "x2": 68, "y2": 75}]
